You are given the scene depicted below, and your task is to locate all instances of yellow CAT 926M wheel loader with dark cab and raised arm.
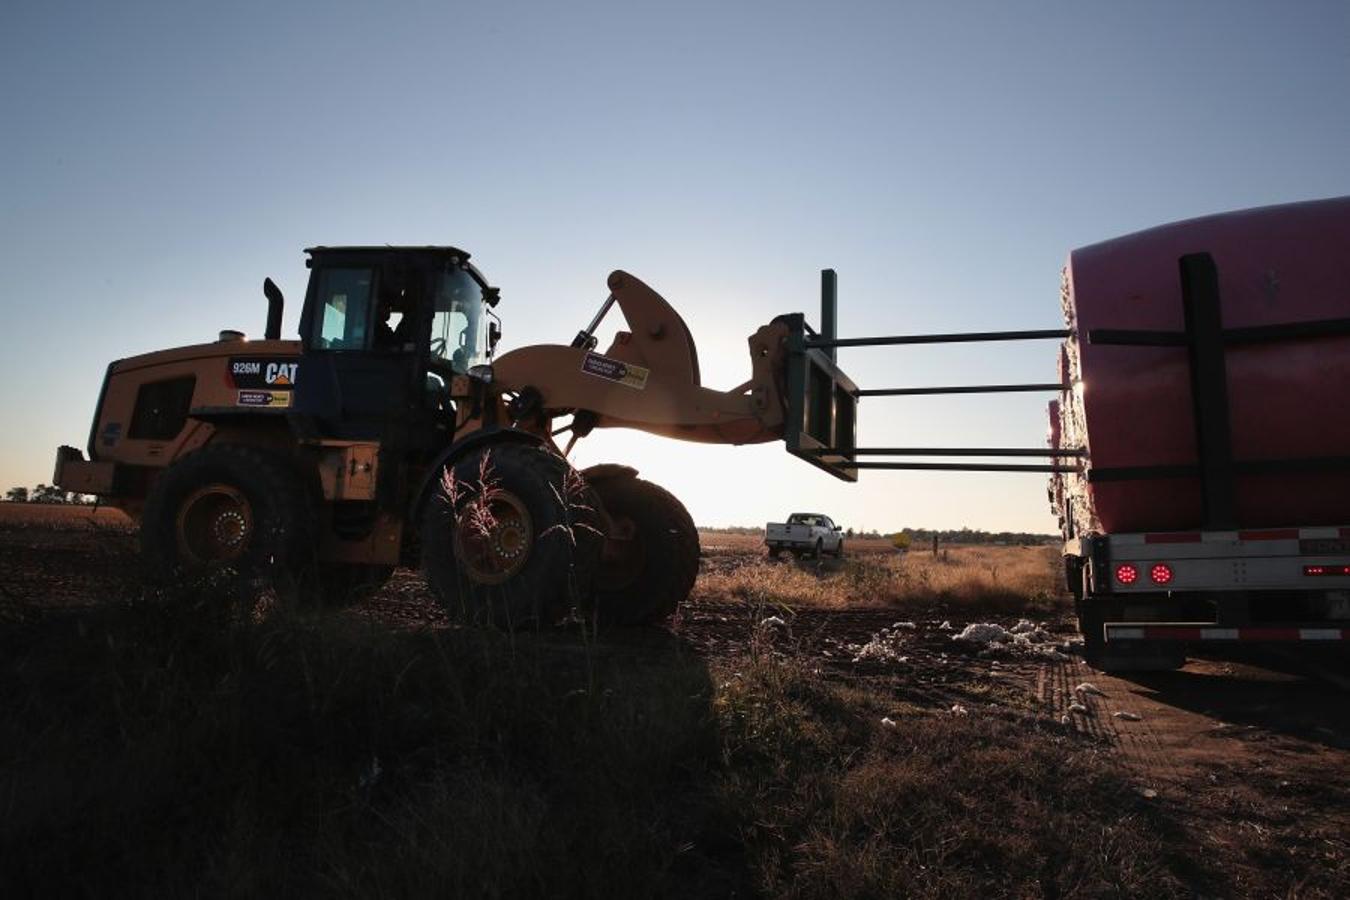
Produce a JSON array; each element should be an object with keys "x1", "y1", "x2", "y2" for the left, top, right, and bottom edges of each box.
[{"x1": 54, "y1": 246, "x2": 853, "y2": 627}]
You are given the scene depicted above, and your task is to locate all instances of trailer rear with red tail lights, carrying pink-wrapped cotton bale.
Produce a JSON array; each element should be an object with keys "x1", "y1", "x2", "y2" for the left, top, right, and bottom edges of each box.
[{"x1": 1050, "y1": 198, "x2": 1350, "y2": 669}]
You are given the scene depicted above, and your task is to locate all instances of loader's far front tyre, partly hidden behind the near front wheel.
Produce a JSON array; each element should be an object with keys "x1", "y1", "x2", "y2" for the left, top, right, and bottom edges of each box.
[{"x1": 594, "y1": 478, "x2": 698, "y2": 625}]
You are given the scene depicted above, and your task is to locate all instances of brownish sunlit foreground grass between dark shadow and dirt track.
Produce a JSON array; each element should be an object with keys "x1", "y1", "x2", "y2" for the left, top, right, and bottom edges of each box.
[{"x1": 716, "y1": 658, "x2": 1236, "y2": 899}]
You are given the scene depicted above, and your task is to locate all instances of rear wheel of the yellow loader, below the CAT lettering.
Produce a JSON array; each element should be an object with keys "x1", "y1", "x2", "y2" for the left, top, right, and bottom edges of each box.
[{"x1": 140, "y1": 444, "x2": 309, "y2": 578}]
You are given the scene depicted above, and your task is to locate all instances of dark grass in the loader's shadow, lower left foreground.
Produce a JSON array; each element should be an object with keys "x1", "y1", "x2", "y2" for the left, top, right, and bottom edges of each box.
[{"x1": 0, "y1": 591, "x2": 743, "y2": 897}]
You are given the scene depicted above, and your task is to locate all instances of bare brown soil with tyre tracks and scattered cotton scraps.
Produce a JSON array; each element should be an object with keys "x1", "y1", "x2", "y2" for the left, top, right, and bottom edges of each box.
[{"x1": 0, "y1": 505, "x2": 1350, "y2": 884}]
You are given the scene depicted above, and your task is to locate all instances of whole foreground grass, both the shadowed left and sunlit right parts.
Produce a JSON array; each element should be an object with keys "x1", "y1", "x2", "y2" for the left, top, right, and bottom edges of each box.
[{"x1": 0, "y1": 598, "x2": 1263, "y2": 897}]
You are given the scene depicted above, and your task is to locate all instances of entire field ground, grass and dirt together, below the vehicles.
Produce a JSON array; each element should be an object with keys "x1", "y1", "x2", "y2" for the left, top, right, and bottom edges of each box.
[{"x1": 0, "y1": 505, "x2": 1350, "y2": 897}]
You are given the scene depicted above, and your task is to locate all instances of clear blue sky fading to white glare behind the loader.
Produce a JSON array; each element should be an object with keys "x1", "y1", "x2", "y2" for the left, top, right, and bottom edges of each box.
[{"x1": 0, "y1": 0, "x2": 1350, "y2": 532}]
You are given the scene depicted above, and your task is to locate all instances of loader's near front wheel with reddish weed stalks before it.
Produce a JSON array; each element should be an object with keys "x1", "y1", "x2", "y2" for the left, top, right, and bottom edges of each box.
[{"x1": 421, "y1": 444, "x2": 601, "y2": 630}]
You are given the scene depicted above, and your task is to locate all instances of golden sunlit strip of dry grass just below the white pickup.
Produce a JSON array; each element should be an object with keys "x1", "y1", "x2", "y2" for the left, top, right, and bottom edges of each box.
[{"x1": 694, "y1": 546, "x2": 1064, "y2": 613}]
